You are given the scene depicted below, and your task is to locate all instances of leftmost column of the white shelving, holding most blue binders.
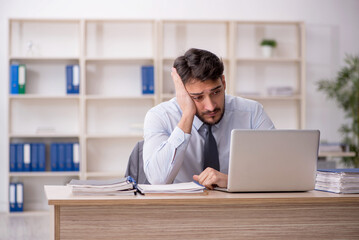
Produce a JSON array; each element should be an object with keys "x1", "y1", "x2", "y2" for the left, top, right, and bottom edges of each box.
[{"x1": 7, "y1": 19, "x2": 81, "y2": 213}]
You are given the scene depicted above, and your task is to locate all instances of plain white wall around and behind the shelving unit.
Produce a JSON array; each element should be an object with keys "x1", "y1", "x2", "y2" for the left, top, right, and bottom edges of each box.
[{"x1": 0, "y1": 0, "x2": 359, "y2": 211}]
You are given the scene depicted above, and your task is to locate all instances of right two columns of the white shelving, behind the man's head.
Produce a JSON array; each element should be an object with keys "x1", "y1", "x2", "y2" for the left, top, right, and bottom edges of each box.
[{"x1": 159, "y1": 20, "x2": 305, "y2": 129}]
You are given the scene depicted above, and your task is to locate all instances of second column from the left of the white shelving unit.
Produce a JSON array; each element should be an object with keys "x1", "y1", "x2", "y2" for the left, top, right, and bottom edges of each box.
[{"x1": 83, "y1": 19, "x2": 159, "y2": 178}]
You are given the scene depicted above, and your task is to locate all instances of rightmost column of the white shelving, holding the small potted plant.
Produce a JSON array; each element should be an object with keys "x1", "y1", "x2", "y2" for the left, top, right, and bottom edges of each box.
[{"x1": 230, "y1": 21, "x2": 305, "y2": 129}]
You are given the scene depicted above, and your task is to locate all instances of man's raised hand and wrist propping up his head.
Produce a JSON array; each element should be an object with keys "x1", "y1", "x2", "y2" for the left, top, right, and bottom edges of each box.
[{"x1": 171, "y1": 68, "x2": 196, "y2": 133}]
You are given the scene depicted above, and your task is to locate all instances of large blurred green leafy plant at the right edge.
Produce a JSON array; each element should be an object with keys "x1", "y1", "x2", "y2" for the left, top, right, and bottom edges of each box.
[{"x1": 317, "y1": 55, "x2": 359, "y2": 168}]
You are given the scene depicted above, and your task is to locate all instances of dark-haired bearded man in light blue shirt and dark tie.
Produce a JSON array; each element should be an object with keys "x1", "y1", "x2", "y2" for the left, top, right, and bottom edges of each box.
[{"x1": 143, "y1": 48, "x2": 274, "y2": 189}]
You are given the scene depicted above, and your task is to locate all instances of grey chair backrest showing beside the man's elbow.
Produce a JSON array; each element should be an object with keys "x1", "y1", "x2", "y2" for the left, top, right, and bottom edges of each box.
[{"x1": 125, "y1": 141, "x2": 149, "y2": 184}]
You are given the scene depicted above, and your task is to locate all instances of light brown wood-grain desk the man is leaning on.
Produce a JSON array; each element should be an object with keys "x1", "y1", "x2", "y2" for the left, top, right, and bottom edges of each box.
[{"x1": 45, "y1": 186, "x2": 359, "y2": 240}]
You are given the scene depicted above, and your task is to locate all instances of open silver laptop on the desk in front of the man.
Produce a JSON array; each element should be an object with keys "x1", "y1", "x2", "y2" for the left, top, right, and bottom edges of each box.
[{"x1": 216, "y1": 129, "x2": 320, "y2": 192}]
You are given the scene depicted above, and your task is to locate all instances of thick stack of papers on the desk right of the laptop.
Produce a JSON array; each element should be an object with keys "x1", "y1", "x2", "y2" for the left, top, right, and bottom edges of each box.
[{"x1": 315, "y1": 168, "x2": 359, "y2": 193}]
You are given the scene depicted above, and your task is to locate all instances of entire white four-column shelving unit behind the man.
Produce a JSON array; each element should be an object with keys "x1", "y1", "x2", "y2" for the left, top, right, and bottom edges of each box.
[{"x1": 7, "y1": 19, "x2": 305, "y2": 212}]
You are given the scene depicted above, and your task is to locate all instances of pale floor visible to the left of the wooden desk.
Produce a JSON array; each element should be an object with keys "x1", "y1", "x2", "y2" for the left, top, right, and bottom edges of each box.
[{"x1": 0, "y1": 212, "x2": 50, "y2": 240}]
